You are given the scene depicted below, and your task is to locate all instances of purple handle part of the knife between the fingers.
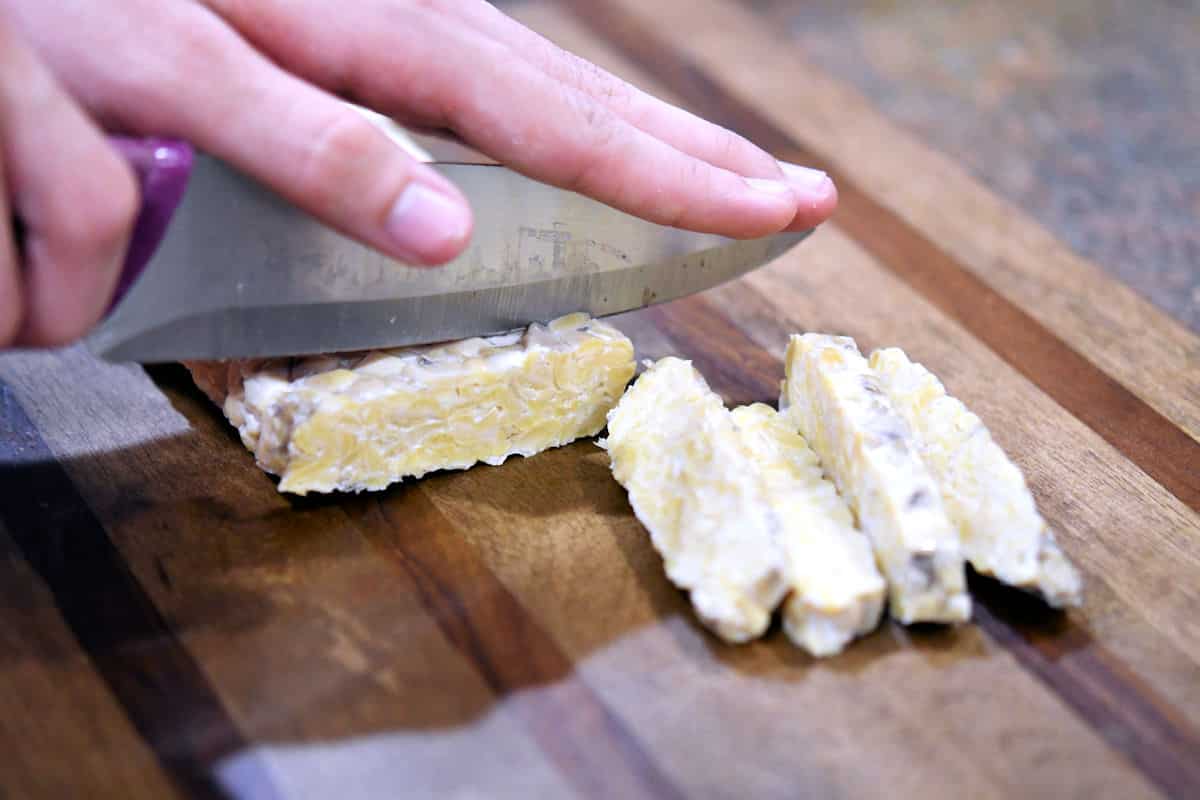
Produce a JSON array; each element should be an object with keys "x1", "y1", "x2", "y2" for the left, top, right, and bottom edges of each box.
[{"x1": 108, "y1": 136, "x2": 194, "y2": 311}]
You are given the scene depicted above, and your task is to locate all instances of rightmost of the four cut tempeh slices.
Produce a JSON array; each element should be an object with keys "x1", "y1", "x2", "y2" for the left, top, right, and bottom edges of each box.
[{"x1": 870, "y1": 348, "x2": 1081, "y2": 608}]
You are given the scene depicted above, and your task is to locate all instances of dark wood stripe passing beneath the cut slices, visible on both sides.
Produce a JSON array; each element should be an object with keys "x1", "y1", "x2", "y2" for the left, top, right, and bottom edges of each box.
[{"x1": 638, "y1": 273, "x2": 1200, "y2": 796}]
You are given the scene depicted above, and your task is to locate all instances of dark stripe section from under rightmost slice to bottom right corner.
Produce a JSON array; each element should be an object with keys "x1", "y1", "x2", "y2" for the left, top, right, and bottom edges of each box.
[{"x1": 971, "y1": 577, "x2": 1200, "y2": 798}]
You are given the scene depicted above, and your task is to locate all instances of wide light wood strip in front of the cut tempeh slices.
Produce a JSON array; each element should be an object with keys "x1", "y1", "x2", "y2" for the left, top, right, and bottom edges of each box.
[{"x1": 424, "y1": 438, "x2": 1150, "y2": 796}]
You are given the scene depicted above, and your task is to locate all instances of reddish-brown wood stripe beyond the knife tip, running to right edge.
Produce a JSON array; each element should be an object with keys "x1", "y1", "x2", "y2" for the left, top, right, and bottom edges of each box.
[{"x1": 565, "y1": 0, "x2": 1200, "y2": 511}]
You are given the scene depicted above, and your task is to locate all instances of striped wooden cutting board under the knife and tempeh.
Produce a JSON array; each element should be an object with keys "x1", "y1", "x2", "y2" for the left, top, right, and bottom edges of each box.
[{"x1": 0, "y1": 0, "x2": 1200, "y2": 799}]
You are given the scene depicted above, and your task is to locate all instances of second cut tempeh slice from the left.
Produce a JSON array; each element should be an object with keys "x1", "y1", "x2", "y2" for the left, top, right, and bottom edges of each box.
[{"x1": 733, "y1": 403, "x2": 887, "y2": 656}]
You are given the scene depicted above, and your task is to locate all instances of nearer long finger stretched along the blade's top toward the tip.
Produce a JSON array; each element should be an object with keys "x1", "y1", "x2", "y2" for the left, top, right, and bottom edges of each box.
[{"x1": 201, "y1": 0, "x2": 797, "y2": 236}]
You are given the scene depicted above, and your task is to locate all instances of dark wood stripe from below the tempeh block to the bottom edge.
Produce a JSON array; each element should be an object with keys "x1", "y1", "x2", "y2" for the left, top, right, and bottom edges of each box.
[{"x1": 347, "y1": 479, "x2": 684, "y2": 798}]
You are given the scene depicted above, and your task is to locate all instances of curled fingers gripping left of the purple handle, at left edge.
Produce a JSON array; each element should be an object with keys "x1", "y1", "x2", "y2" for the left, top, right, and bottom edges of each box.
[{"x1": 0, "y1": 20, "x2": 138, "y2": 345}]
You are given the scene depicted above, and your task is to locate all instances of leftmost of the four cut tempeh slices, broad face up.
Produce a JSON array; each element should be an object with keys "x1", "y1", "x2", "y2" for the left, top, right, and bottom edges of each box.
[{"x1": 601, "y1": 357, "x2": 788, "y2": 642}]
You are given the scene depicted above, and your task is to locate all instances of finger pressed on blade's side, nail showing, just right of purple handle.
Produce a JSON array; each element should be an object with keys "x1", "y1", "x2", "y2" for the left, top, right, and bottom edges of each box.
[{"x1": 37, "y1": 0, "x2": 472, "y2": 264}]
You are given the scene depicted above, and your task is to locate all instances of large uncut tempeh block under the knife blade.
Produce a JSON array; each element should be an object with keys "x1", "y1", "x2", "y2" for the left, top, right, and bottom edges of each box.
[{"x1": 187, "y1": 314, "x2": 635, "y2": 494}]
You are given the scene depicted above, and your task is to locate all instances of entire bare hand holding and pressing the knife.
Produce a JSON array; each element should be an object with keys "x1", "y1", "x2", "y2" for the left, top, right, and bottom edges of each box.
[{"x1": 0, "y1": 0, "x2": 838, "y2": 348}]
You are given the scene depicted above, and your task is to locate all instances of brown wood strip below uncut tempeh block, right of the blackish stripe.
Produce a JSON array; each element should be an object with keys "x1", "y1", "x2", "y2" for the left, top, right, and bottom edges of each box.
[{"x1": 0, "y1": 355, "x2": 580, "y2": 798}]
